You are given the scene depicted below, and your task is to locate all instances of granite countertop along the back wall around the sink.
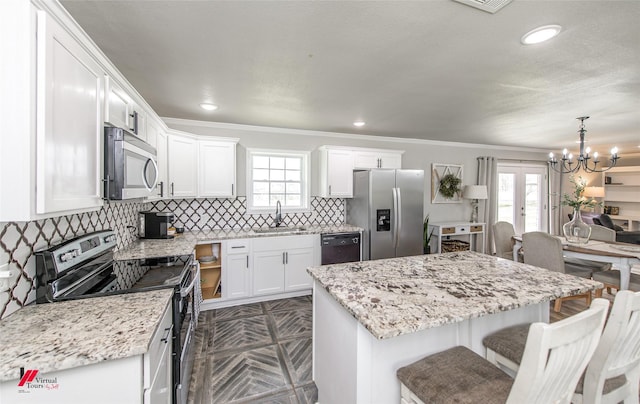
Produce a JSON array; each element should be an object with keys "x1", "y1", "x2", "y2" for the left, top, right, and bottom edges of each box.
[{"x1": 114, "y1": 224, "x2": 362, "y2": 260}]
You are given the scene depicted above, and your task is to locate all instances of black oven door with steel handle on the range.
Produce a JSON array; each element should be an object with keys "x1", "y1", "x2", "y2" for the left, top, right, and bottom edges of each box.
[{"x1": 174, "y1": 261, "x2": 198, "y2": 404}]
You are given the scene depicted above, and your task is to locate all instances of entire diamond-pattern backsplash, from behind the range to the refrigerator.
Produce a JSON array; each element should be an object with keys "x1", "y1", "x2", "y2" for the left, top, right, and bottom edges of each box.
[{"x1": 0, "y1": 197, "x2": 346, "y2": 318}]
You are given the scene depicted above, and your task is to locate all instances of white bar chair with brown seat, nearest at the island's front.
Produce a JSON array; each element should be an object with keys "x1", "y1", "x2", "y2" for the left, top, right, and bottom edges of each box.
[{"x1": 397, "y1": 299, "x2": 609, "y2": 404}]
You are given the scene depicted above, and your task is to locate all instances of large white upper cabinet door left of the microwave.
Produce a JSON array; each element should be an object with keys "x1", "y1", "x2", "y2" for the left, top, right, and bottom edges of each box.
[{"x1": 36, "y1": 11, "x2": 105, "y2": 214}]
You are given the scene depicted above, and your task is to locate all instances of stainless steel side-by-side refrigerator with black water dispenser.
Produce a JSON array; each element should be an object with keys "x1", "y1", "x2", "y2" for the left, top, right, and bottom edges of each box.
[{"x1": 347, "y1": 169, "x2": 424, "y2": 260}]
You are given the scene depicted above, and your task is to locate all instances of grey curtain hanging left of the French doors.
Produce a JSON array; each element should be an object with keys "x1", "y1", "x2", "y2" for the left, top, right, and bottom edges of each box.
[{"x1": 477, "y1": 156, "x2": 498, "y2": 254}]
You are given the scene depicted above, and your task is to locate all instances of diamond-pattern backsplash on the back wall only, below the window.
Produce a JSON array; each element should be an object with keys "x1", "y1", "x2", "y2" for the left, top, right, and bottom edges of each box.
[{"x1": 151, "y1": 197, "x2": 346, "y2": 231}]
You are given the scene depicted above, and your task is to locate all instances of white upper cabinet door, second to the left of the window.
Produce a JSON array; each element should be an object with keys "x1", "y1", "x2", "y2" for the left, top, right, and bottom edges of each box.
[{"x1": 167, "y1": 134, "x2": 198, "y2": 198}]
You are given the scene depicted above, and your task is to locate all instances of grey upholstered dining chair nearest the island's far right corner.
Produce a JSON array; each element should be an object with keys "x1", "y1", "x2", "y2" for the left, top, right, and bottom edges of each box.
[{"x1": 522, "y1": 231, "x2": 593, "y2": 312}]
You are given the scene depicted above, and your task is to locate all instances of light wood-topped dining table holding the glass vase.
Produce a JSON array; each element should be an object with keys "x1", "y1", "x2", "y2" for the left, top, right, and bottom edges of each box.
[{"x1": 512, "y1": 235, "x2": 640, "y2": 290}]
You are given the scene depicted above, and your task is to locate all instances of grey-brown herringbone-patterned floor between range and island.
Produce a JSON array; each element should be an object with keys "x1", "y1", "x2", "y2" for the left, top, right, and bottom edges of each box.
[{"x1": 188, "y1": 296, "x2": 318, "y2": 404}]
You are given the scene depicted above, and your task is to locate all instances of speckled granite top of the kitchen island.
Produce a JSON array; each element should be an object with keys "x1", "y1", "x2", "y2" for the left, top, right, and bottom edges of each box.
[{"x1": 307, "y1": 251, "x2": 602, "y2": 339}]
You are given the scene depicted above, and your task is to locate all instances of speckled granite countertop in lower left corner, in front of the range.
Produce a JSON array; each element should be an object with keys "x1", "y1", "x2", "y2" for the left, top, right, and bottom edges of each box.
[{"x1": 0, "y1": 289, "x2": 173, "y2": 381}]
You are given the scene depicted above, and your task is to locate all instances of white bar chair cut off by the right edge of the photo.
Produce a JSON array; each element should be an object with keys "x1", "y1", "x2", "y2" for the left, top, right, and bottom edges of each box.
[{"x1": 482, "y1": 290, "x2": 640, "y2": 404}]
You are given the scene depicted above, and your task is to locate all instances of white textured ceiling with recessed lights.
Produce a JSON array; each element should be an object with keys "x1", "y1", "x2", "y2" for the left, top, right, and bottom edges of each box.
[{"x1": 62, "y1": 0, "x2": 640, "y2": 153}]
